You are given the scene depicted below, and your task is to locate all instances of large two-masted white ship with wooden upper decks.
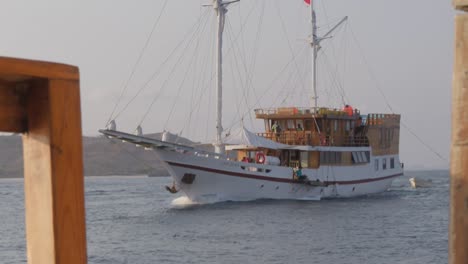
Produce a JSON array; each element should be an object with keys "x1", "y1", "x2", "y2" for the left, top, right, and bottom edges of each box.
[{"x1": 100, "y1": 0, "x2": 403, "y2": 203}]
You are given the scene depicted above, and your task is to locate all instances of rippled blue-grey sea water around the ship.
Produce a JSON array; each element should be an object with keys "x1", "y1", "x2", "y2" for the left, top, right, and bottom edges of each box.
[{"x1": 0, "y1": 171, "x2": 449, "y2": 264}]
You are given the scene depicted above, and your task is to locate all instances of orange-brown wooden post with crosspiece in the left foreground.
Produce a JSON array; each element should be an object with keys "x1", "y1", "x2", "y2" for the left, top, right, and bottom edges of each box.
[{"x1": 0, "y1": 57, "x2": 87, "y2": 264}]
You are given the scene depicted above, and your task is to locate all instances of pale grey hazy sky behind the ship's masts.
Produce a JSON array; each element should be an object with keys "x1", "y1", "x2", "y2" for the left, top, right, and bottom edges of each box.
[{"x1": 0, "y1": 0, "x2": 455, "y2": 169}]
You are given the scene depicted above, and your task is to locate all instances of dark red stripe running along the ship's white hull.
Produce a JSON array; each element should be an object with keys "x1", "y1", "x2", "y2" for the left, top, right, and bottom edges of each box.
[{"x1": 167, "y1": 161, "x2": 403, "y2": 185}]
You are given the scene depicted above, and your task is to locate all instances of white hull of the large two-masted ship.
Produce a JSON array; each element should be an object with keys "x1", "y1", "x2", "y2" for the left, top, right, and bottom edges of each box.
[{"x1": 155, "y1": 149, "x2": 403, "y2": 203}]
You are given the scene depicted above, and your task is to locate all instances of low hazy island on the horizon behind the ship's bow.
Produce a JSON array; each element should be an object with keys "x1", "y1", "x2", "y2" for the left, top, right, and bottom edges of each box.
[{"x1": 0, "y1": 133, "x2": 203, "y2": 178}]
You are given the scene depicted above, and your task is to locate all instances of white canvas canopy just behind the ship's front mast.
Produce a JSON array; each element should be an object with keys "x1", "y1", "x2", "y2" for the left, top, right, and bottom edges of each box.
[{"x1": 224, "y1": 127, "x2": 288, "y2": 150}]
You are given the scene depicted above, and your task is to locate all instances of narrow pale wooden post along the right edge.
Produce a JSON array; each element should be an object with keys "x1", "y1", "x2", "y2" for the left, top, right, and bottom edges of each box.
[{"x1": 449, "y1": 0, "x2": 468, "y2": 264}]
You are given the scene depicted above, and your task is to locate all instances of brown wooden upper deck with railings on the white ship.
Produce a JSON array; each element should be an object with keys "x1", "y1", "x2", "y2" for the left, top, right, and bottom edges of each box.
[{"x1": 255, "y1": 107, "x2": 400, "y2": 155}]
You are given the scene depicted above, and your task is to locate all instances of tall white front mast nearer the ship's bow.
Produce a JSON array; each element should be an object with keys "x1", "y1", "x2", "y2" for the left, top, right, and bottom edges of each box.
[{"x1": 213, "y1": 0, "x2": 240, "y2": 154}]
